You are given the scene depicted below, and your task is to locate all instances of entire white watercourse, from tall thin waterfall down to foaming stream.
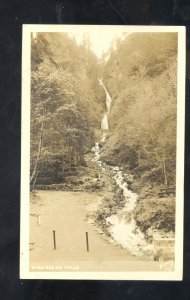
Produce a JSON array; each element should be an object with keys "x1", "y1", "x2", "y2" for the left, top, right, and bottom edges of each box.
[{"x1": 92, "y1": 79, "x2": 152, "y2": 256}]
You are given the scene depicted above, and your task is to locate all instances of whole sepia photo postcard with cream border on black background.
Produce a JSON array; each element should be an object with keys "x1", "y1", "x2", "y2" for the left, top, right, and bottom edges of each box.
[{"x1": 20, "y1": 25, "x2": 185, "y2": 280}]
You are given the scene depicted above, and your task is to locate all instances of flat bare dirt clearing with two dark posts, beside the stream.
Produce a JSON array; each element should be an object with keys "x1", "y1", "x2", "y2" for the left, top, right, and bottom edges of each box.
[{"x1": 30, "y1": 191, "x2": 160, "y2": 271}]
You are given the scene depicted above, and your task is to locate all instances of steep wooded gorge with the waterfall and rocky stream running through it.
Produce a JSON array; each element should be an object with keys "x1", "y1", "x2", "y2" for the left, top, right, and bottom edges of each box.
[{"x1": 31, "y1": 33, "x2": 177, "y2": 260}]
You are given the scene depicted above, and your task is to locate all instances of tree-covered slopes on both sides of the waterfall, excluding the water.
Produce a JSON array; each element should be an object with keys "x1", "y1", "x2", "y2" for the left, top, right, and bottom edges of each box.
[{"x1": 30, "y1": 33, "x2": 177, "y2": 195}]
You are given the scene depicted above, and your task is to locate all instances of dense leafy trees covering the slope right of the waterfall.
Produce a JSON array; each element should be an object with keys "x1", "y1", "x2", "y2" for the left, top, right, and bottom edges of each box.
[{"x1": 102, "y1": 33, "x2": 177, "y2": 185}]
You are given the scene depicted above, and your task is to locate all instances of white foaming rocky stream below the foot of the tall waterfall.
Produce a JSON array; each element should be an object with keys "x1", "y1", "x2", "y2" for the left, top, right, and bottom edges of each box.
[{"x1": 92, "y1": 142, "x2": 153, "y2": 256}]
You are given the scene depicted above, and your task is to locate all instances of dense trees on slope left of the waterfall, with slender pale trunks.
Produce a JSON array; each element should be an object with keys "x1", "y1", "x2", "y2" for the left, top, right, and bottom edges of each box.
[{"x1": 31, "y1": 33, "x2": 103, "y2": 185}]
